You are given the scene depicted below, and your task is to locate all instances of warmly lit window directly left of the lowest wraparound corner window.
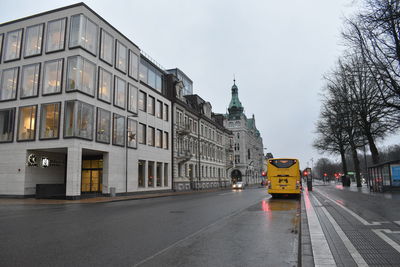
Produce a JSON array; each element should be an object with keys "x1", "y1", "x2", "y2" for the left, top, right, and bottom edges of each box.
[{"x1": 39, "y1": 103, "x2": 61, "y2": 139}]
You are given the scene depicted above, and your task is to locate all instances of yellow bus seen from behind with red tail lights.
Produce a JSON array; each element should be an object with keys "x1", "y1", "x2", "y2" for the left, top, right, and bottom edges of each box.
[{"x1": 267, "y1": 158, "x2": 301, "y2": 197}]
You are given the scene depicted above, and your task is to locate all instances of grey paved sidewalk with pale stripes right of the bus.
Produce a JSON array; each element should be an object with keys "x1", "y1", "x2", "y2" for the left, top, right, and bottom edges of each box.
[{"x1": 303, "y1": 183, "x2": 400, "y2": 266}]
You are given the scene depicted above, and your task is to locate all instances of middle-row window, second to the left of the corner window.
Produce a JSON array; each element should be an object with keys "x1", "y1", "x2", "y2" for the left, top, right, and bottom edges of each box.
[{"x1": 20, "y1": 63, "x2": 40, "y2": 98}]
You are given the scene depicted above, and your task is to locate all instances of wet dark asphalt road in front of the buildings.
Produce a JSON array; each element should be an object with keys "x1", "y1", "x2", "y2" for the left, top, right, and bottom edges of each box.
[{"x1": 0, "y1": 188, "x2": 300, "y2": 266}]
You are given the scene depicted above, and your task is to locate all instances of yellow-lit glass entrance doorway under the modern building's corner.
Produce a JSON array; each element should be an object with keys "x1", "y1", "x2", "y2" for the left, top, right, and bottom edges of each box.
[{"x1": 81, "y1": 157, "x2": 103, "y2": 193}]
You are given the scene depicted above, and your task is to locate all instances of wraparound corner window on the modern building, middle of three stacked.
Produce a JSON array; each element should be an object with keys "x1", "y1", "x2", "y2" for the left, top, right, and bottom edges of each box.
[{"x1": 67, "y1": 56, "x2": 96, "y2": 96}]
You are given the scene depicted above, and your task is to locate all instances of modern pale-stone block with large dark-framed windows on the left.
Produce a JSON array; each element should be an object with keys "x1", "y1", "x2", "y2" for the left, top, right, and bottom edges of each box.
[{"x1": 0, "y1": 3, "x2": 171, "y2": 199}]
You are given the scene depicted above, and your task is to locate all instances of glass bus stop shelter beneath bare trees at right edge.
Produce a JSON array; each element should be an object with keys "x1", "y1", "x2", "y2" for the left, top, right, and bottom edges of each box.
[{"x1": 368, "y1": 160, "x2": 400, "y2": 192}]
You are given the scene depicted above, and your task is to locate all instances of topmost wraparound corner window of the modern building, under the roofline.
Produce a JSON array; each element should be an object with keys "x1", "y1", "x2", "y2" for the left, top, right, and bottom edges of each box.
[{"x1": 69, "y1": 14, "x2": 98, "y2": 55}]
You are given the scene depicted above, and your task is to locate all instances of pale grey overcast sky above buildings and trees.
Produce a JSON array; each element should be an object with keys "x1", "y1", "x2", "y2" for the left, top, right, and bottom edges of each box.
[{"x1": 0, "y1": 0, "x2": 400, "y2": 167}]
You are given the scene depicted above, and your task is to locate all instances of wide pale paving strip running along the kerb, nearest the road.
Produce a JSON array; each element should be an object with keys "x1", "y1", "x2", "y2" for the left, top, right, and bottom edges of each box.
[{"x1": 303, "y1": 191, "x2": 336, "y2": 266}]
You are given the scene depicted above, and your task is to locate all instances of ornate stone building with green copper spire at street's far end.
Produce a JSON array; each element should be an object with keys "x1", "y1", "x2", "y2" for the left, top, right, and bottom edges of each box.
[{"x1": 224, "y1": 80, "x2": 264, "y2": 184}]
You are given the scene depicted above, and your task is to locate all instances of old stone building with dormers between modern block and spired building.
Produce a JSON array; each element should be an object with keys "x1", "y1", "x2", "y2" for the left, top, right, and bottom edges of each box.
[{"x1": 167, "y1": 69, "x2": 233, "y2": 191}]
